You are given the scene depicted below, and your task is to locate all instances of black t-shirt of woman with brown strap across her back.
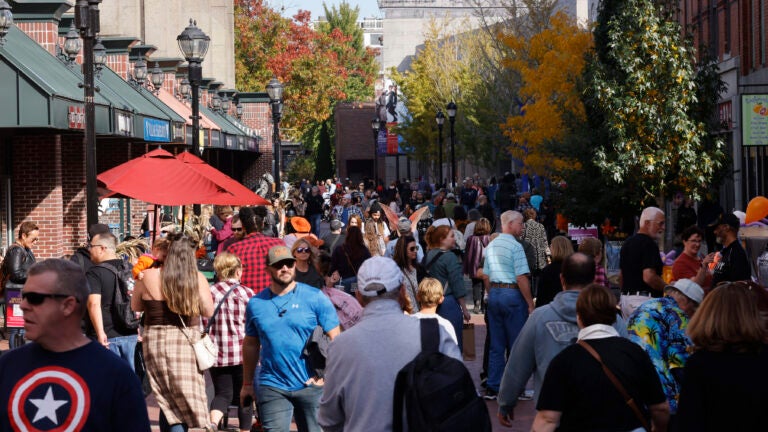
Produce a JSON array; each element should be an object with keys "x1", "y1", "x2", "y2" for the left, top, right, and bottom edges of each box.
[{"x1": 536, "y1": 337, "x2": 666, "y2": 432}]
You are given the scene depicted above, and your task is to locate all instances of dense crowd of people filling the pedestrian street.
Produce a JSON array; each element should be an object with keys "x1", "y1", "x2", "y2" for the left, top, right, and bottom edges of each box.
[{"x1": 0, "y1": 175, "x2": 768, "y2": 432}]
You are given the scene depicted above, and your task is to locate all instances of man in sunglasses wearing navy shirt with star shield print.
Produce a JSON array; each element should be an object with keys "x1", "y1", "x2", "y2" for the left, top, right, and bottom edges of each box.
[{"x1": 0, "y1": 259, "x2": 150, "y2": 432}]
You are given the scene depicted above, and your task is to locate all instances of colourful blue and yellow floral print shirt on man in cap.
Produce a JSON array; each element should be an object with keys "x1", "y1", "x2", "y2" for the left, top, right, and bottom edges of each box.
[{"x1": 627, "y1": 297, "x2": 693, "y2": 414}]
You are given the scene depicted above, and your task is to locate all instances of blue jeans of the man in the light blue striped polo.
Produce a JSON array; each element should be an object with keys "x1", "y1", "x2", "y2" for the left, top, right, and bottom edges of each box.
[{"x1": 487, "y1": 288, "x2": 528, "y2": 391}]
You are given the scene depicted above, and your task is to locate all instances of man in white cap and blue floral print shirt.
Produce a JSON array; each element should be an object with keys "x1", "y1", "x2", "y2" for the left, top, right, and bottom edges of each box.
[{"x1": 627, "y1": 279, "x2": 704, "y2": 422}]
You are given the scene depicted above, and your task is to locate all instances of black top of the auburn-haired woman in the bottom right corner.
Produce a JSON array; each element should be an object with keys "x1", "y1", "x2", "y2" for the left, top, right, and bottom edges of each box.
[{"x1": 677, "y1": 344, "x2": 768, "y2": 432}]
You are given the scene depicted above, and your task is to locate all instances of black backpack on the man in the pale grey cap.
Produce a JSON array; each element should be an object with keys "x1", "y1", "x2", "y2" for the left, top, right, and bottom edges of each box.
[{"x1": 392, "y1": 318, "x2": 492, "y2": 432}]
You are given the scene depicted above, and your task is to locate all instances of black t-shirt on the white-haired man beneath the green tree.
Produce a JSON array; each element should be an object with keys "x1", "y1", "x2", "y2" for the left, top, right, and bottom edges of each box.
[{"x1": 619, "y1": 234, "x2": 664, "y2": 297}]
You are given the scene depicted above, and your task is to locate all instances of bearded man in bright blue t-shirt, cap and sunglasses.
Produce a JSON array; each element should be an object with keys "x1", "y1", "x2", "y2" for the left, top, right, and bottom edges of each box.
[{"x1": 240, "y1": 246, "x2": 339, "y2": 432}]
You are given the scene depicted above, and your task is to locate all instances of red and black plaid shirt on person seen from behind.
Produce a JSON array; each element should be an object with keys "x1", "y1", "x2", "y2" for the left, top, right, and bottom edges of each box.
[{"x1": 227, "y1": 233, "x2": 285, "y2": 294}]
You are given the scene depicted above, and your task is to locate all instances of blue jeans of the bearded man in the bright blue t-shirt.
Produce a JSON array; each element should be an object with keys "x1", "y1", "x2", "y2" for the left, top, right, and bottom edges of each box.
[{"x1": 256, "y1": 385, "x2": 323, "y2": 432}]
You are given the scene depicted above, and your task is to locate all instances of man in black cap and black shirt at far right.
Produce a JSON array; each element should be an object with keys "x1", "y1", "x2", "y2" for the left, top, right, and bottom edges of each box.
[{"x1": 712, "y1": 213, "x2": 752, "y2": 288}]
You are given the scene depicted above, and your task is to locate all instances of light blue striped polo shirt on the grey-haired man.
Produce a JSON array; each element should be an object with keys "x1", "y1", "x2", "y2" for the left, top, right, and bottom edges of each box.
[{"x1": 483, "y1": 234, "x2": 531, "y2": 283}]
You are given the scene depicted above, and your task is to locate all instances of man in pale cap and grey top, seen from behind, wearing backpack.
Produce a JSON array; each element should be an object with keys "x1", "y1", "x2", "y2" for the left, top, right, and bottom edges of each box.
[{"x1": 318, "y1": 256, "x2": 461, "y2": 431}]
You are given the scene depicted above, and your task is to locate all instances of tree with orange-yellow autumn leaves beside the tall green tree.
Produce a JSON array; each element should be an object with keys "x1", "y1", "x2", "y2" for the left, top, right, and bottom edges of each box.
[{"x1": 499, "y1": 11, "x2": 593, "y2": 177}]
